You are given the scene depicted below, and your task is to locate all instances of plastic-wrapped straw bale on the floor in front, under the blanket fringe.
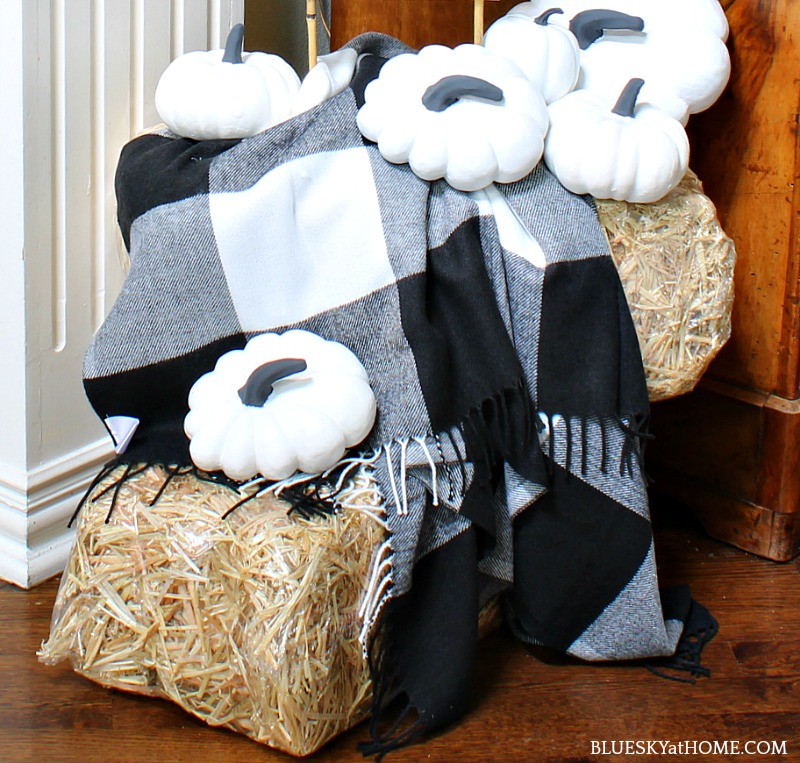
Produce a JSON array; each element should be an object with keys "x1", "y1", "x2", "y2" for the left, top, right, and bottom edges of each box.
[{"x1": 40, "y1": 467, "x2": 385, "y2": 755}]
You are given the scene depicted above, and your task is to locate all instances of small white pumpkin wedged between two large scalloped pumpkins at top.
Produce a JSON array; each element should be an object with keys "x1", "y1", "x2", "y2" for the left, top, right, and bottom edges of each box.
[{"x1": 483, "y1": 8, "x2": 580, "y2": 103}]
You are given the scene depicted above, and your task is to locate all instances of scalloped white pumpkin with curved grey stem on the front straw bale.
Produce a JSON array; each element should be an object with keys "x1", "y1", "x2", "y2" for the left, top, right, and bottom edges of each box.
[{"x1": 184, "y1": 329, "x2": 376, "y2": 481}]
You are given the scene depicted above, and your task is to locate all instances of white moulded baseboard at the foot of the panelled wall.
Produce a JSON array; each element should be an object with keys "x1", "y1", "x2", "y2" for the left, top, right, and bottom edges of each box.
[{"x1": 0, "y1": 438, "x2": 113, "y2": 588}]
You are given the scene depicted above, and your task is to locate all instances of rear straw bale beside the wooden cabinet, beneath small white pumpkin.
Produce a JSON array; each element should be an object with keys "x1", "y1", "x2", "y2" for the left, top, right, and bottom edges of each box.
[{"x1": 597, "y1": 171, "x2": 736, "y2": 401}]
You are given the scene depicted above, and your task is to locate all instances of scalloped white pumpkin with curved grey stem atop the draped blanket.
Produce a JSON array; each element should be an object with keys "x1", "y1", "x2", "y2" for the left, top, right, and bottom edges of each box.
[{"x1": 358, "y1": 44, "x2": 547, "y2": 191}]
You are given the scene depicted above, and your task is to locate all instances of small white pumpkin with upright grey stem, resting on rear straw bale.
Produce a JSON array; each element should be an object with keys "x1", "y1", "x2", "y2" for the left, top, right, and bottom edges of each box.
[{"x1": 544, "y1": 79, "x2": 689, "y2": 202}]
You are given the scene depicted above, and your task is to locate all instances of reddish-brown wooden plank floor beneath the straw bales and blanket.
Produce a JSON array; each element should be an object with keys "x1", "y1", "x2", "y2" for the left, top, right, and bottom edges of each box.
[{"x1": 0, "y1": 507, "x2": 800, "y2": 763}]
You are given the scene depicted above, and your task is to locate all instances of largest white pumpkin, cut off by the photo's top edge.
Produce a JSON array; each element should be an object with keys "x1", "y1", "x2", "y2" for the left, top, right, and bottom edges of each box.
[{"x1": 509, "y1": 0, "x2": 731, "y2": 124}]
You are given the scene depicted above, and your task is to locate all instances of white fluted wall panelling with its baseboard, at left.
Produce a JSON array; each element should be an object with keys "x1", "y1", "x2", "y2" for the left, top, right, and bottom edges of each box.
[{"x1": 0, "y1": 0, "x2": 244, "y2": 587}]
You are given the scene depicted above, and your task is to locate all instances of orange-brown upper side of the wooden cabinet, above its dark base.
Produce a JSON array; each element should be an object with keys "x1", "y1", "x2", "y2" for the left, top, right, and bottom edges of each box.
[{"x1": 689, "y1": 0, "x2": 800, "y2": 399}]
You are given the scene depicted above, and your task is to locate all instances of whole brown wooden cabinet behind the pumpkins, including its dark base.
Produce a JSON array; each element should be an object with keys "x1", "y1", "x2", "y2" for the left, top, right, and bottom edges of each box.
[{"x1": 332, "y1": 0, "x2": 800, "y2": 560}]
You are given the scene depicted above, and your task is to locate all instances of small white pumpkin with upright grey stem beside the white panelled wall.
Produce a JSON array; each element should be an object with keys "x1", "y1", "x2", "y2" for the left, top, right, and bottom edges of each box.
[{"x1": 155, "y1": 24, "x2": 300, "y2": 140}]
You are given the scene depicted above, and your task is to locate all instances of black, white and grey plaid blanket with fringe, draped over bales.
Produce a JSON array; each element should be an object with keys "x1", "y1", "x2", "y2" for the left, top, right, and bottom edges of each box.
[{"x1": 85, "y1": 35, "x2": 720, "y2": 752}]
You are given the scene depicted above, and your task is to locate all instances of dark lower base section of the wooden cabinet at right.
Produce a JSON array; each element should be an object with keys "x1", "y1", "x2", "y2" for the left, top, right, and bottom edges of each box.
[{"x1": 647, "y1": 380, "x2": 800, "y2": 561}]
